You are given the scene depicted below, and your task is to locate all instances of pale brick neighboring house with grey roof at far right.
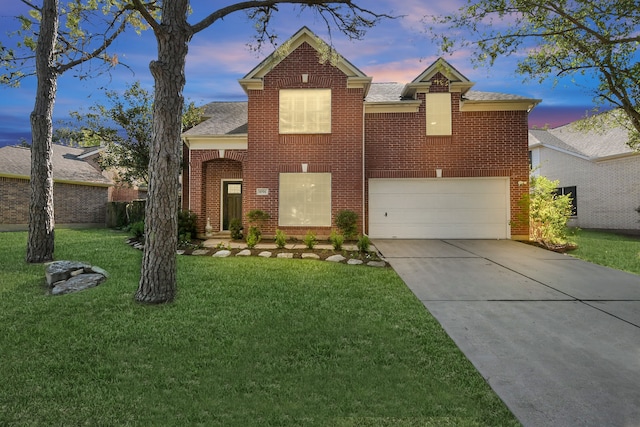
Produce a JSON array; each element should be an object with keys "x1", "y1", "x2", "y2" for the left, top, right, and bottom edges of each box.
[{"x1": 529, "y1": 118, "x2": 640, "y2": 232}]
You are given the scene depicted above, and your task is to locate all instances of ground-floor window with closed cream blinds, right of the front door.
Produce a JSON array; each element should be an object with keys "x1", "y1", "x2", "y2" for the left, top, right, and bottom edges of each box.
[{"x1": 278, "y1": 173, "x2": 331, "y2": 227}]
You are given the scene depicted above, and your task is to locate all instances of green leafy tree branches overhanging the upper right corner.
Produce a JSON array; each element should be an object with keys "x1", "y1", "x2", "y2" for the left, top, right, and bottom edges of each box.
[{"x1": 431, "y1": 0, "x2": 640, "y2": 148}]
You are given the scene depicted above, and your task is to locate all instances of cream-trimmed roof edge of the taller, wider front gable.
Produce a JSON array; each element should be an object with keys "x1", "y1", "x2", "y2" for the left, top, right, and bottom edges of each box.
[{"x1": 239, "y1": 26, "x2": 371, "y2": 94}]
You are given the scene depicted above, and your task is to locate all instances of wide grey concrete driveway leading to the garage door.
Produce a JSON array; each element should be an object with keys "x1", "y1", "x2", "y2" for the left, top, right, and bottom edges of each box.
[{"x1": 374, "y1": 240, "x2": 640, "y2": 427}]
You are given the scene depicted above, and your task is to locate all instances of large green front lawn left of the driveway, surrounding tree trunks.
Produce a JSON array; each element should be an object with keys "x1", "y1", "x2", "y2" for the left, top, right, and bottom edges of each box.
[{"x1": 0, "y1": 230, "x2": 518, "y2": 426}]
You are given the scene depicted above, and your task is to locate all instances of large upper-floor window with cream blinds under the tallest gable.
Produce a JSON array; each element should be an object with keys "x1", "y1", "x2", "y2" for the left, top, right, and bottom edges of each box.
[{"x1": 280, "y1": 89, "x2": 331, "y2": 134}]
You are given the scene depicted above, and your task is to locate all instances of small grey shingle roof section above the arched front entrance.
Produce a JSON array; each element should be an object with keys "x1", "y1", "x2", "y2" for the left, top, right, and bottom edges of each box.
[{"x1": 183, "y1": 101, "x2": 248, "y2": 136}]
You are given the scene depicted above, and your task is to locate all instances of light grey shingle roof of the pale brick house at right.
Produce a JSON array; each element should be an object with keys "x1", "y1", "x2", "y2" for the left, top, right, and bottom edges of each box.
[{"x1": 529, "y1": 112, "x2": 640, "y2": 161}]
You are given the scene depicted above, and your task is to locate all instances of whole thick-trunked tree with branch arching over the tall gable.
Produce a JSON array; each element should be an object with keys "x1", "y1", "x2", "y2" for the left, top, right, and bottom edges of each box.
[{"x1": 131, "y1": 0, "x2": 390, "y2": 303}]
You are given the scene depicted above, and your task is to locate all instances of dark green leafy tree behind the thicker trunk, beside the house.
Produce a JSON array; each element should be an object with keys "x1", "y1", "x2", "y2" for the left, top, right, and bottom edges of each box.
[{"x1": 54, "y1": 82, "x2": 203, "y2": 185}]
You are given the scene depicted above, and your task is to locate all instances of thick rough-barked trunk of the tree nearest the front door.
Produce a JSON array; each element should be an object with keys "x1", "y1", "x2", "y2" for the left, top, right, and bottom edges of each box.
[{"x1": 135, "y1": 0, "x2": 192, "y2": 304}]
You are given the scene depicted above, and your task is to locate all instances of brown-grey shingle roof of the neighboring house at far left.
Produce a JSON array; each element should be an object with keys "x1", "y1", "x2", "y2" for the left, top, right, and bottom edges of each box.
[{"x1": 0, "y1": 144, "x2": 112, "y2": 185}]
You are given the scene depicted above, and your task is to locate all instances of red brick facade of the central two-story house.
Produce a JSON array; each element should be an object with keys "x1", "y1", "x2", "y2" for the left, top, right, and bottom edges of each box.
[{"x1": 183, "y1": 28, "x2": 529, "y2": 236}]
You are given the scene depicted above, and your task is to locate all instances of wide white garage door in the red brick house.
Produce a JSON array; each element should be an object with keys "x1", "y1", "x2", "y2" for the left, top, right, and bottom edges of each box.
[{"x1": 369, "y1": 178, "x2": 511, "y2": 239}]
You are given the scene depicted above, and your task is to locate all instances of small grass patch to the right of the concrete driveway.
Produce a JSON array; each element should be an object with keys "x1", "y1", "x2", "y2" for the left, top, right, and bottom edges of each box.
[{"x1": 569, "y1": 230, "x2": 640, "y2": 274}]
